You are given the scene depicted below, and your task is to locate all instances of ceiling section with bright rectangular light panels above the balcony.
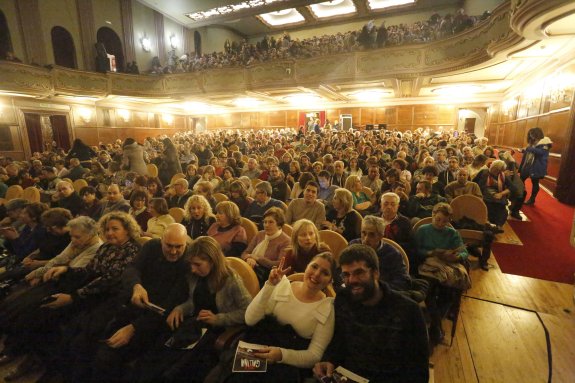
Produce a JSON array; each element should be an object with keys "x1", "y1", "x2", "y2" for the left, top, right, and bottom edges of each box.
[{"x1": 134, "y1": 0, "x2": 460, "y2": 37}]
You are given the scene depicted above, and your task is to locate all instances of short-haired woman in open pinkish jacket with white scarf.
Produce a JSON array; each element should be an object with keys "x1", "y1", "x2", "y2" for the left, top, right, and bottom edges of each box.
[{"x1": 242, "y1": 208, "x2": 291, "y2": 286}]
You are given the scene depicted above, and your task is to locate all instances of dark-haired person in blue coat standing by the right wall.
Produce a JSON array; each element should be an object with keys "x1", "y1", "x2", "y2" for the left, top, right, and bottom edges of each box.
[{"x1": 519, "y1": 128, "x2": 553, "y2": 205}]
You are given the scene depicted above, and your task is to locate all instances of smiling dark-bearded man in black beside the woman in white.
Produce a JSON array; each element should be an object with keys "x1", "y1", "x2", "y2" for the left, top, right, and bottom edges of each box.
[{"x1": 313, "y1": 244, "x2": 429, "y2": 383}]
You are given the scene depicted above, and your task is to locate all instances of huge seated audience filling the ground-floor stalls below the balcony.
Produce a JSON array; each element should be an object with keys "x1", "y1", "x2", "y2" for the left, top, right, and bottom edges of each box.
[{"x1": 0, "y1": 121, "x2": 551, "y2": 382}]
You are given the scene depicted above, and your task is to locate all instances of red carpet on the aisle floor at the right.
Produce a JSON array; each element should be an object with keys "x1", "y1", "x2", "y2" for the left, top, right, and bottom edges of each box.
[{"x1": 492, "y1": 180, "x2": 575, "y2": 284}]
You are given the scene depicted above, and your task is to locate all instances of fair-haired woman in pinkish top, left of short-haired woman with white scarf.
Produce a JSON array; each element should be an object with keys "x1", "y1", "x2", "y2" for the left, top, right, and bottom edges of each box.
[{"x1": 208, "y1": 201, "x2": 248, "y2": 257}]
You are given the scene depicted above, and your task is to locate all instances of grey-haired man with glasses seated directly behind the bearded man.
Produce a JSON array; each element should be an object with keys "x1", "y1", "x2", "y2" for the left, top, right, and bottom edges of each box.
[{"x1": 350, "y1": 215, "x2": 411, "y2": 290}]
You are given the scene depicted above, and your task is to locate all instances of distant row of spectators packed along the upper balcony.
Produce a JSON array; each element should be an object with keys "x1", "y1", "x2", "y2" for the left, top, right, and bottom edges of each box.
[{"x1": 152, "y1": 9, "x2": 489, "y2": 73}]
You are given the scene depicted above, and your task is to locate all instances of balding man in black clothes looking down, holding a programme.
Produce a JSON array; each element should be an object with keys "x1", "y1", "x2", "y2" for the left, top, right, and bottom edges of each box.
[{"x1": 62, "y1": 223, "x2": 190, "y2": 382}]
